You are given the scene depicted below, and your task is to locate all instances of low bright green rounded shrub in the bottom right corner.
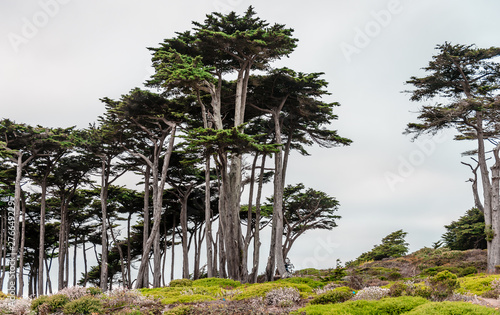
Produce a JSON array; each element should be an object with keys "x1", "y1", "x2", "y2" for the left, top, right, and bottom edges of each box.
[{"x1": 406, "y1": 302, "x2": 498, "y2": 315}]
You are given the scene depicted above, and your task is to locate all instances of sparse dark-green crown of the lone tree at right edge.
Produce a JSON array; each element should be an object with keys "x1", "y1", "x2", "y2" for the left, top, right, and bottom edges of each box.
[{"x1": 407, "y1": 43, "x2": 500, "y2": 139}]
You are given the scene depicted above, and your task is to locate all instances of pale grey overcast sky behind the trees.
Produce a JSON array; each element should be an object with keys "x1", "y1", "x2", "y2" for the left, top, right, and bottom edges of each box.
[{"x1": 0, "y1": 0, "x2": 500, "y2": 276}]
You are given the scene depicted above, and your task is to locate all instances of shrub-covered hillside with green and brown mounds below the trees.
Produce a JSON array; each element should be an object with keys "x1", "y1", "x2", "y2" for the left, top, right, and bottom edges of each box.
[{"x1": 0, "y1": 248, "x2": 500, "y2": 315}]
